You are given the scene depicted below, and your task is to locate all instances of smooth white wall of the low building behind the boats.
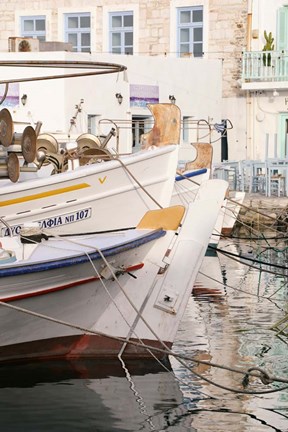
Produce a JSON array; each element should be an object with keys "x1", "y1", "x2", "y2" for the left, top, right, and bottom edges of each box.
[{"x1": 0, "y1": 52, "x2": 222, "y2": 161}]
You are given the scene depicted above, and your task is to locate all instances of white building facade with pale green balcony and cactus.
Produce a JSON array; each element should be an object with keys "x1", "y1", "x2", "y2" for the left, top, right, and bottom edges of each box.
[{"x1": 239, "y1": 0, "x2": 288, "y2": 159}]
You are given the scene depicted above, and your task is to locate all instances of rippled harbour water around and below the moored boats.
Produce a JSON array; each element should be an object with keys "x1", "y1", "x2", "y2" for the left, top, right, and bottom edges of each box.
[{"x1": 0, "y1": 240, "x2": 288, "y2": 432}]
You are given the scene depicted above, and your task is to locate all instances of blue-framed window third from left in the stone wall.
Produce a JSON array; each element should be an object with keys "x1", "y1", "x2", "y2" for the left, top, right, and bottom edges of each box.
[{"x1": 109, "y1": 12, "x2": 133, "y2": 54}]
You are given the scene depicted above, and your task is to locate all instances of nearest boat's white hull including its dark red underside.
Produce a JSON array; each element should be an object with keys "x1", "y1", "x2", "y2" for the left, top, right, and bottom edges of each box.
[{"x1": 0, "y1": 226, "x2": 187, "y2": 362}]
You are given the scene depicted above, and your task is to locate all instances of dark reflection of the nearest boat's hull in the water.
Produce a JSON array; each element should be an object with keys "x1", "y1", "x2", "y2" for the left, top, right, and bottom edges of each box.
[{"x1": 0, "y1": 360, "x2": 191, "y2": 432}]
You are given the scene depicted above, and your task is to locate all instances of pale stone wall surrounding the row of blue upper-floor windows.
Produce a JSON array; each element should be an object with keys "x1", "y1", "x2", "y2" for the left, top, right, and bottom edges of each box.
[{"x1": 0, "y1": 0, "x2": 248, "y2": 97}]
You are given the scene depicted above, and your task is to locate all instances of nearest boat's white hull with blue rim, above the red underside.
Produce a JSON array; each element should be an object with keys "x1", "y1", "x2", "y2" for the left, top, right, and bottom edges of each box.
[{"x1": 0, "y1": 231, "x2": 171, "y2": 352}]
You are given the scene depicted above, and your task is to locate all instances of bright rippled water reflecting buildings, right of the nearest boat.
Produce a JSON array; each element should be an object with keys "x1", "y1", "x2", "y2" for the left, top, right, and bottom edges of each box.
[{"x1": 172, "y1": 241, "x2": 288, "y2": 432}]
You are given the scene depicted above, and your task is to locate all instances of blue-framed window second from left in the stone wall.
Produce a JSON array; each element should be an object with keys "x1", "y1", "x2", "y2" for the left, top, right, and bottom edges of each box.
[{"x1": 65, "y1": 13, "x2": 91, "y2": 52}]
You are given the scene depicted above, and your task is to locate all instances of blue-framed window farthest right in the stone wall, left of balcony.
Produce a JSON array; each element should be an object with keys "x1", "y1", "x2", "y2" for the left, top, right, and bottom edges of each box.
[{"x1": 178, "y1": 6, "x2": 203, "y2": 57}]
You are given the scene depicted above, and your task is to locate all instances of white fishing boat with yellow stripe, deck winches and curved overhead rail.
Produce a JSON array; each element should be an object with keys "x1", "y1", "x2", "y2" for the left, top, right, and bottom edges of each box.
[{"x1": 0, "y1": 61, "x2": 184, "y2": 235}]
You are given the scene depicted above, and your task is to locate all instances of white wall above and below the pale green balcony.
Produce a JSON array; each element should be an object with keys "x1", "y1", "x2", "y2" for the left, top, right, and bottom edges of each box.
[{"x1": 242, "y1": 0, "x2": 288, "y2": 160}]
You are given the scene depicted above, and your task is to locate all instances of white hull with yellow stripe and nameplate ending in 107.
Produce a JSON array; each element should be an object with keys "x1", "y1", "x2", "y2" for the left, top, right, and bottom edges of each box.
[{"x1": 0, "y1": 145, "x2": 178, "y2": 235}]
